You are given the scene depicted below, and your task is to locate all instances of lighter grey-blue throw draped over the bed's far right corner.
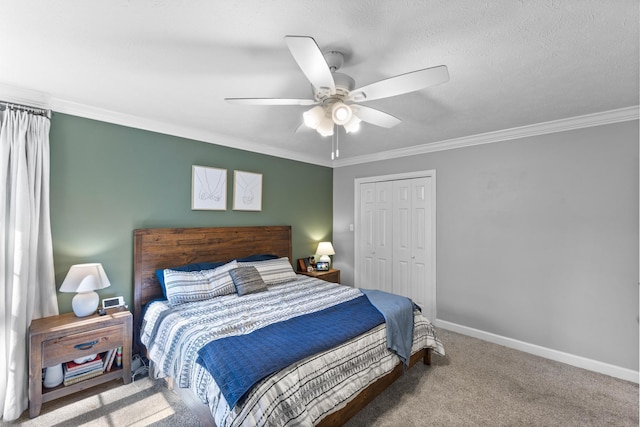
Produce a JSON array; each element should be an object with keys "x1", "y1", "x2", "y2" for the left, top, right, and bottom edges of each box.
[{"x1": 360, "y1": 289, "x2": 413, "y2": 366}]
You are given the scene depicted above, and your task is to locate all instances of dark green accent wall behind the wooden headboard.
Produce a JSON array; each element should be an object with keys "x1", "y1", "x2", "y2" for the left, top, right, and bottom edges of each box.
[{"x1": 50, "y1": 113, "x2": 333, "y2": 313}]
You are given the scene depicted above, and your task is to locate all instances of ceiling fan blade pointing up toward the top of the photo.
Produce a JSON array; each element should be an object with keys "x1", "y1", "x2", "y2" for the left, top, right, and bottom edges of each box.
[{"x1": 284, "y1": 36, "x2": 336, "y2": 95}]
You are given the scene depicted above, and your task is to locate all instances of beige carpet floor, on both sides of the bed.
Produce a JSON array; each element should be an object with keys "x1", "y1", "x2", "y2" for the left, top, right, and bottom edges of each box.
[{"x1": 5, "y1": 330, "x2": 639, "y2": 427}]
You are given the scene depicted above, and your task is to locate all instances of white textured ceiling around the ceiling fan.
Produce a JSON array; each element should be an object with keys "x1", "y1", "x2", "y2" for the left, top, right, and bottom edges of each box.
[{"x1": 0, "y1": 0, "x2": 640, "y2": 166}]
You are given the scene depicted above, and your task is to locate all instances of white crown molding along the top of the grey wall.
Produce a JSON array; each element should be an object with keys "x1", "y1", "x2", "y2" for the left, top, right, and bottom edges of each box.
[{"x1": 333, "y1": 105, "x2": 640, "y2": 167}]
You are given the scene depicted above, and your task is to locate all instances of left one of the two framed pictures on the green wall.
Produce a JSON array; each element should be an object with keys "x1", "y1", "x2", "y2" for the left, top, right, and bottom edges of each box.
[{"x1": 191, "y1": 165, "x2": 227, "y2": 211}]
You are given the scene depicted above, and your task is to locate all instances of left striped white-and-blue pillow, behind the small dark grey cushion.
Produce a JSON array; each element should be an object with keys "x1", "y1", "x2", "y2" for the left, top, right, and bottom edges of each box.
[{"x1": 164, "y1": 261, "x2": 238, "y2": 304}]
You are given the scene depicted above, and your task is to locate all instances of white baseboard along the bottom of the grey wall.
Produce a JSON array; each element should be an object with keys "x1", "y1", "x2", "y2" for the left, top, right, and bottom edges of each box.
[{"x1": 433, "y1": 319, "x2": 640, "y2": 384}]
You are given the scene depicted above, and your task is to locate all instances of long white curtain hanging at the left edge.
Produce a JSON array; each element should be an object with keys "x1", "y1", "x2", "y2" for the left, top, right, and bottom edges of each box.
[{"x1": 0, "y1": 106, "x2": 58, "y2": 421}]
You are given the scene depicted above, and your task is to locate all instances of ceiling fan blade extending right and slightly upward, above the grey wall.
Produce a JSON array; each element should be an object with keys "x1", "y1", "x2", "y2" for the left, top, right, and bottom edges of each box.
[{"x1": 348, "y1": 65, "x2": 449, "y2": 102}]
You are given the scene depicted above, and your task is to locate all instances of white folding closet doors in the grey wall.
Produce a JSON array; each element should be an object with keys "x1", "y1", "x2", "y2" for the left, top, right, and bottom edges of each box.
[{"x1": 356, "y1": 174, "x2": 436, "y2": 320}]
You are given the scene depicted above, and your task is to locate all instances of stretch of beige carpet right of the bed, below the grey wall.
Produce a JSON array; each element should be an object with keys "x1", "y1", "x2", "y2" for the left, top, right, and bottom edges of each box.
[{"x1": 347, "y1": 330, "x2": 638, "y2": 427}]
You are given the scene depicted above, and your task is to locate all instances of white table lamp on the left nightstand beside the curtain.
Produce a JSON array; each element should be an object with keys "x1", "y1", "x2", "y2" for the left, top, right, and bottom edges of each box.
[{"x1": 60, "y1": 263, "x2": 111, "y2": 317}]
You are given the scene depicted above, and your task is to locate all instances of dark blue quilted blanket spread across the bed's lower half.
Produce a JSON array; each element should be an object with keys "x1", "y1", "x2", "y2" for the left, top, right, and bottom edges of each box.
[{"x1": 198, "y1": 295, "x2": 384, "y2": 408}]
